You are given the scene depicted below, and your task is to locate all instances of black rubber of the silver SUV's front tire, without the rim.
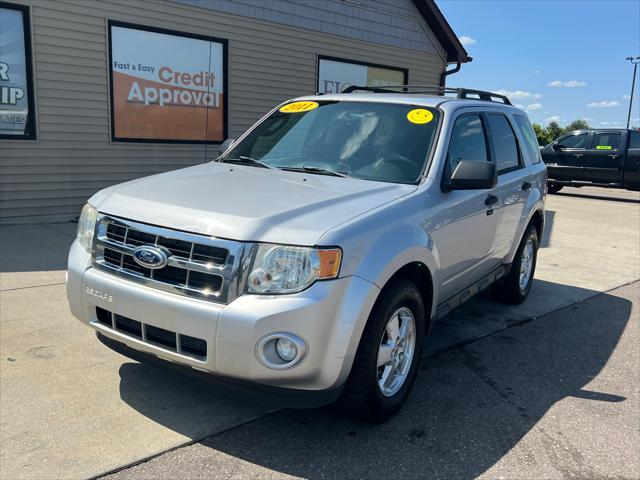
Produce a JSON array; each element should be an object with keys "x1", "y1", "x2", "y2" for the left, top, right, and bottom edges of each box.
[{"x1": 336, "y1": 279, "x2": 426, "y2": 423}]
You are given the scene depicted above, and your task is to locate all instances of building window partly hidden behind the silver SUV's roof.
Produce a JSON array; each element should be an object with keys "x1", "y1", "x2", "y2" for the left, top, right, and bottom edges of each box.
[{"x1": 316, "y1": 55, "x2": 409, "y2": 93}]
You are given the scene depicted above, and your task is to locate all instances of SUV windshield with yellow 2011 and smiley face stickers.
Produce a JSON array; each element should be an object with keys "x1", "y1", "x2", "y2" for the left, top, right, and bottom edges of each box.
[{"x1": 220, "y1": 101, "x2": 439, "y2": 183}]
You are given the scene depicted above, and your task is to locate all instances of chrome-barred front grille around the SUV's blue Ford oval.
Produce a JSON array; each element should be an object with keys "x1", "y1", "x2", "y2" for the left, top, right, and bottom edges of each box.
[{"x1": 93, "y1": 215, "x2": 244, "y2": 303}]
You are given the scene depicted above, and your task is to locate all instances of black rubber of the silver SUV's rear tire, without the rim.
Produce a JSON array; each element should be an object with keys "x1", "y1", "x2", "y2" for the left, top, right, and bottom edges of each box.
[{"x1": 491, "y1": 225, "x2": 539, "y2": 305}]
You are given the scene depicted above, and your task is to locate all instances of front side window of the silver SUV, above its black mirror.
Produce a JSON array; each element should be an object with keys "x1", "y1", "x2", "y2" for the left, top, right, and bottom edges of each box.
[{"x1": 445, "y1": 114, "x2": 489, "y2": 178}]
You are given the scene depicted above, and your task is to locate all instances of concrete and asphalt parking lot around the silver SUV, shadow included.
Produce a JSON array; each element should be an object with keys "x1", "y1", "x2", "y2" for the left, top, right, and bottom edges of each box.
[{"x1": 0, "y1": 188, "x2": 640, "y2": 479}]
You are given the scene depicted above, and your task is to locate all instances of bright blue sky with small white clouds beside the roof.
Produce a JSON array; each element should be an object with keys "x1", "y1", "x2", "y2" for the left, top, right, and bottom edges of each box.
[{"x1": 437, "y1": 0, "x2": 640, "y2": 128}]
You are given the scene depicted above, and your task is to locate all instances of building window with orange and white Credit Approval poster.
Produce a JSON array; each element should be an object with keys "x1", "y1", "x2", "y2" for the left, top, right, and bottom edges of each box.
[{"x1": 109, "y1": 22, "x2": 228, "y2": 143}]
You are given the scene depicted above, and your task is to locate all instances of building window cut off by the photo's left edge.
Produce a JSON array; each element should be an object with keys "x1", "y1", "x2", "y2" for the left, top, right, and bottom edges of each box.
[{"x1": 0, "y1": 2, "x2": 36, "y2": 140}]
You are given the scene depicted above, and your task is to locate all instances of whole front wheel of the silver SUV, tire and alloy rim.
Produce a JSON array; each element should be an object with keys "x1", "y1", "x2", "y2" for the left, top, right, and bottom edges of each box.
[{"x1": 338, "y1": 280, "x2": 426, "y2": 422}]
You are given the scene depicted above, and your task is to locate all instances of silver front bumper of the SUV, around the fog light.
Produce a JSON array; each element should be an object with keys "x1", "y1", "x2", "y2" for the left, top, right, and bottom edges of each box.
[{"x1": 67, "y1": 242, "x2": 379, "y2": 391}]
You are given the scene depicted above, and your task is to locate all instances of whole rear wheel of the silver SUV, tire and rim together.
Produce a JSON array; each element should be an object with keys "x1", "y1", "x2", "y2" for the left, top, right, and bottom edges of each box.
[{"x1": 492, "y1": 225, "x2": 538, "y2": 305}]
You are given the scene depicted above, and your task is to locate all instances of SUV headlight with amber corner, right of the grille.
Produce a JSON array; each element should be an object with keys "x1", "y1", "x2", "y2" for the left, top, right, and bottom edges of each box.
[{"x1": 247, "y1": 244, "x2": 342, "y2": 294}]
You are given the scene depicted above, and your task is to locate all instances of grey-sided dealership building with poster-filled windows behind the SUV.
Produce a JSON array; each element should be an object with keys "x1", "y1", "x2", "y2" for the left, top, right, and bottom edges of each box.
[{"x1": 0, "y1": 0, "x2": 470, "y2": 224}]
